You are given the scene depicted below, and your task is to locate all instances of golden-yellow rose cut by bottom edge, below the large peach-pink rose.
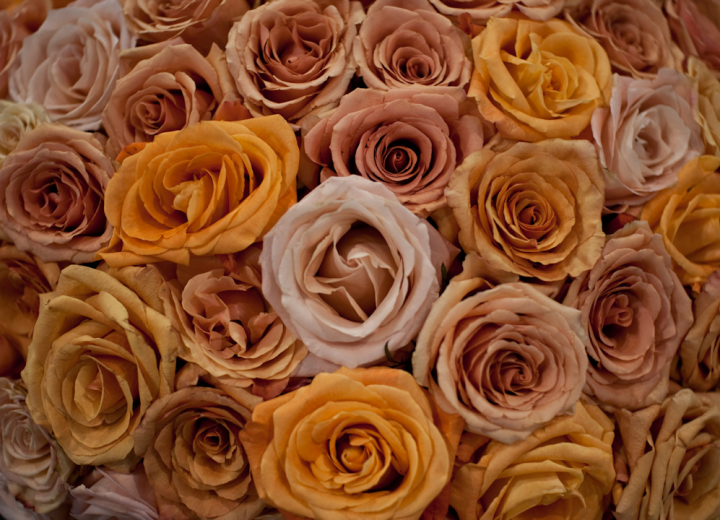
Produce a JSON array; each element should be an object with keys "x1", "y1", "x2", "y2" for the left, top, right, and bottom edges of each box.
[{"x1": 450, "y1": 402, "x2": 615, "y2": 520}]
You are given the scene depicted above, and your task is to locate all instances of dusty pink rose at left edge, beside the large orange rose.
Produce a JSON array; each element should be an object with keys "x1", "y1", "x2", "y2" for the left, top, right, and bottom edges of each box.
[{"x1": 0, "y1": 123, "x2": 115, "y2": 263}]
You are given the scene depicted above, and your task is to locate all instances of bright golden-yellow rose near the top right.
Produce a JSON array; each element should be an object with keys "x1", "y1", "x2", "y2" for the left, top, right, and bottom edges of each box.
[{"x1": 468, "y1": 17, "x2": 612, "y2": 141}]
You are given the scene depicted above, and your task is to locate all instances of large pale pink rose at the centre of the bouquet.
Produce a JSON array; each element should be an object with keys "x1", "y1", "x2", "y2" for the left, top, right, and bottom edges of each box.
[{"x1": 260, "y1": 175, "x2": 457, "y2": 369}]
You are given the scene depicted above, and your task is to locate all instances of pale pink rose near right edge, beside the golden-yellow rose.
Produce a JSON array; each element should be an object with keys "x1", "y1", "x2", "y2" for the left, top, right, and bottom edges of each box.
[{"x1": 591, "y1": 68, "x2": 705, "y2": 207}]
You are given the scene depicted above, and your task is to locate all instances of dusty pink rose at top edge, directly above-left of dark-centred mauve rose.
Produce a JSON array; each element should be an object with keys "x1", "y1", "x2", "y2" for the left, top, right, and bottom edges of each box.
[{"x1": 226, "y1": 0, "x2": 364, "y2": 124}]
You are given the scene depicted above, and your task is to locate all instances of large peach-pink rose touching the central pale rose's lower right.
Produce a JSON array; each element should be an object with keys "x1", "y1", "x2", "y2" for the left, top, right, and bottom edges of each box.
[{"x1": 413, "y1": 254, "x2": 587, "y2": 443}]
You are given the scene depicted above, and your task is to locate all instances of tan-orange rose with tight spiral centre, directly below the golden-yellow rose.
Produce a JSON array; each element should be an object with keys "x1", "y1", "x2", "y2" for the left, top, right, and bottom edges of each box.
[{"x1": 445, "y1": 139, "x2": 604, "y2": 281}]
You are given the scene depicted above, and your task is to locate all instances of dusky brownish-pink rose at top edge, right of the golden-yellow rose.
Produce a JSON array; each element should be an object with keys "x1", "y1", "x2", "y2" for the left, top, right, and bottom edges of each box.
[{"x1": 566, "y1": 0, "x2": 683, "y2": 79}]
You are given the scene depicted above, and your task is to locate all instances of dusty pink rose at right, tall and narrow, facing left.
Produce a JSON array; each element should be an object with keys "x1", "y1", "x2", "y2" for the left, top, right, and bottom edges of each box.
[{"x1": 563, "y1": 220, "x2": 692, "y2": 410}]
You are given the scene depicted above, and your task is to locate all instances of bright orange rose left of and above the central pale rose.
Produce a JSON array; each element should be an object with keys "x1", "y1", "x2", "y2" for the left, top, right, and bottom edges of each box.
[{"x1": 99, "y1": 116, "x2": 300, "y2": 267}]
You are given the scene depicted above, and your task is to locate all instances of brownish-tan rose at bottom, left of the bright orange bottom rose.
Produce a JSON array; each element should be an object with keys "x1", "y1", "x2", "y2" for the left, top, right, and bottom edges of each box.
[{"x1": 135, "y1": 371, "x2": 265, "y2": 520}]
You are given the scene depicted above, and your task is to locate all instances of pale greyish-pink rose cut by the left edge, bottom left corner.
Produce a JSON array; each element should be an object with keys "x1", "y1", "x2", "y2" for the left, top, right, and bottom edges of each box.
[{"x1": 0, "y1": 377, "x2": 75, "y2": 514}]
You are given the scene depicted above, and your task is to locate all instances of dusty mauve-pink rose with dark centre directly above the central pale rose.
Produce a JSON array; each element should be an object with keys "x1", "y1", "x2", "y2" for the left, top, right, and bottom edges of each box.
[{"x1": 303, "y1": 89, "x2": 487, "y2": 217}]
